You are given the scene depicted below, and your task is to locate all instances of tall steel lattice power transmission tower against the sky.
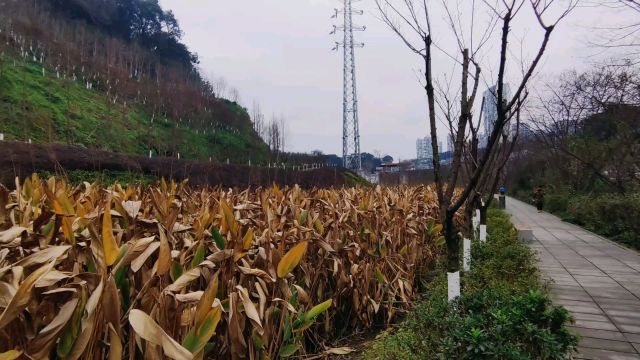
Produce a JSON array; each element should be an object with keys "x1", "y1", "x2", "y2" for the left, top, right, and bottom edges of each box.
[{"x1": 331, "y1": 0, "x2": 366, "y2": 171}]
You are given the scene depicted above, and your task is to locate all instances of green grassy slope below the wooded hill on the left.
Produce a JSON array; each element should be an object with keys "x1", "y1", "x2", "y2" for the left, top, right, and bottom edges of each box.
[{"x1": 0, "y1": 55, "x2": 269, "y2": 163}]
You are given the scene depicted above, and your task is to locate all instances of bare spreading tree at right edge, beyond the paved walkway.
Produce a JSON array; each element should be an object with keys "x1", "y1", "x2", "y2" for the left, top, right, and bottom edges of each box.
[{"x1": 530, "y1": 63, "x2": 640, "y2": 192}]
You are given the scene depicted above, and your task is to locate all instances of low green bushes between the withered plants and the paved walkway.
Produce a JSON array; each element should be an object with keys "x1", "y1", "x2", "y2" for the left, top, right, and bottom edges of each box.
[{"x1": 364, "y1": 209, "x2": 577, "y2": 360}]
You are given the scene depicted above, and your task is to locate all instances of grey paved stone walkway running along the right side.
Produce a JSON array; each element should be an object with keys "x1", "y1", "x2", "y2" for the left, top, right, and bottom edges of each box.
[{"x1": 507, "y1": 198, "x2": 640, "y2": 360}]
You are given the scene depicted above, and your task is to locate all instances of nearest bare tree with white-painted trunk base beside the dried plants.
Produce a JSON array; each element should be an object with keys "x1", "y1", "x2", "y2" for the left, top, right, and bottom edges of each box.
[{"x1": 376, "y1": 0, "x2": 575, "y2": 278}]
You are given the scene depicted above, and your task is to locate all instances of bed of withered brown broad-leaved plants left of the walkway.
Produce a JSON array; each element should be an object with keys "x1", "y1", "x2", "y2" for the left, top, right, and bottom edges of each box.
[{"x1": 0, "y1": 175, "x2": 444, "y2": 359}]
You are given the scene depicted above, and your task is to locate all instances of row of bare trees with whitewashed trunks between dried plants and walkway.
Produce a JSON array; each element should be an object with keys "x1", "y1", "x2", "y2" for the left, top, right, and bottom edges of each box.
[{"x1": 376, "y1": 0, "x2": 576, "y2": 293}]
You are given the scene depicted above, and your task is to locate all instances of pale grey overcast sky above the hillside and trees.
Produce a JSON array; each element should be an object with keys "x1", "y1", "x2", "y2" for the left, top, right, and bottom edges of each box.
[{"x1": 160, "y1": 0, "x2": 637, "y2": 159}]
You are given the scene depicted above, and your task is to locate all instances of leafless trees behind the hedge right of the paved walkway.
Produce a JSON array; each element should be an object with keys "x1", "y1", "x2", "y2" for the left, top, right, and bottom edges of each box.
[{"x1": 509, "y1": 61, "x2": 640, "y2": 193}]
